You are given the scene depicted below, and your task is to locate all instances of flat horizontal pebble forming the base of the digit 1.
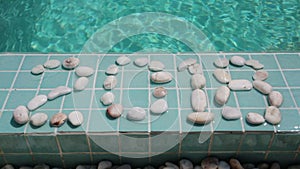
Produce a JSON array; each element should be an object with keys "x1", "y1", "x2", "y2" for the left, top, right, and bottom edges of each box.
[{"x1": 187, "y1": 112, "x2": 214, "y2": 124}]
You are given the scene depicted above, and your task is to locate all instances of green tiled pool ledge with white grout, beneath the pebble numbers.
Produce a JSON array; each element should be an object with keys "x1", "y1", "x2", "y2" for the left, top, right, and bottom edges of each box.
[{"x1": 0, "y1": 53, "x2": 300, "y2": 168}]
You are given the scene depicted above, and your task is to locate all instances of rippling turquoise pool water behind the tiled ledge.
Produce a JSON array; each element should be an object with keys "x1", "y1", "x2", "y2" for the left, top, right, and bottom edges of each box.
[{"x1": 0, "y1": 0, "x2": 300, "y2": 53}]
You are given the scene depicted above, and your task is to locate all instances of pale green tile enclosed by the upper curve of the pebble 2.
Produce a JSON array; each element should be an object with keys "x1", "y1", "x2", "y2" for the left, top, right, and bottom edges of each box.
[{"x1": 41, "y1": 72, "x2": 72, "y2": 88}]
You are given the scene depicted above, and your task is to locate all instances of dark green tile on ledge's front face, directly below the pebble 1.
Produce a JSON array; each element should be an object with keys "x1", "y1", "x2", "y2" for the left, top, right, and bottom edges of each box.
[{"x1": 181, "y1": 133, "x2": 210, "y2": 154}]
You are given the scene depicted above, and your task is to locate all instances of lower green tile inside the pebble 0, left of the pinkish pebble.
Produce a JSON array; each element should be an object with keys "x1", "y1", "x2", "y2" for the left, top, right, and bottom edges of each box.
[{"x1": 121, "y1": 89, "x2": 149, "y2": 108}]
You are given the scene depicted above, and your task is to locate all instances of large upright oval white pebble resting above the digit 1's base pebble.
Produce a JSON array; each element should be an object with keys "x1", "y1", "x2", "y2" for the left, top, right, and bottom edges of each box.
[{"x1": 191, "y1": 89, "x2": 207, "y2": 112}]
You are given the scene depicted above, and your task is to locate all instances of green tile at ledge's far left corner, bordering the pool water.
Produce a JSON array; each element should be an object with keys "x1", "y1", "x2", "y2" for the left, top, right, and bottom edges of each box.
[{"x1": 0, "y1": 56, "x2": 22, "y2": 70}]
